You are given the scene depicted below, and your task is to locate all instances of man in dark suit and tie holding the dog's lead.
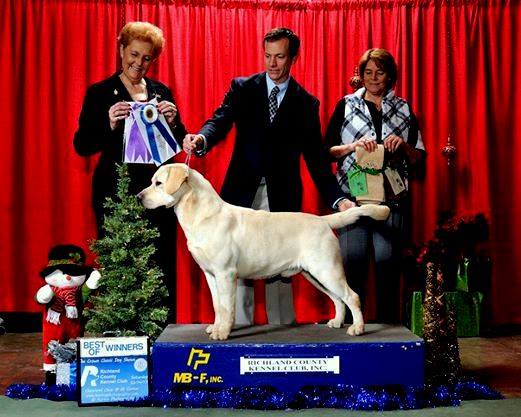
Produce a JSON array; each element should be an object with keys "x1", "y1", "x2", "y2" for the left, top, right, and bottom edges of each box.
[{"x1": 183, "y1": 28, "x2": 351, "y2": 324}]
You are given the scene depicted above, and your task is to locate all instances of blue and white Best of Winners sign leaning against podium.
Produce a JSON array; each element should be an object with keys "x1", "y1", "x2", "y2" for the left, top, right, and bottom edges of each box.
[{"x1": 76, "y1": 337, "x2": 150, "y2": 406}]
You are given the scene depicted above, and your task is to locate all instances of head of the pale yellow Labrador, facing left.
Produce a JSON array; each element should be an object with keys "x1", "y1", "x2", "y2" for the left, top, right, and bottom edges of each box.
[{"x1": 137, "y1": 164, "x2": 189, "y2": 209}]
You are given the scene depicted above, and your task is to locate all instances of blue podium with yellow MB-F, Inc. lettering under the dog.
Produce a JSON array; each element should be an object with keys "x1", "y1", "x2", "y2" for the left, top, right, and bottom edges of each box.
[{"x1": 152, "y1": 324, "x2": 424, "y2": 393}]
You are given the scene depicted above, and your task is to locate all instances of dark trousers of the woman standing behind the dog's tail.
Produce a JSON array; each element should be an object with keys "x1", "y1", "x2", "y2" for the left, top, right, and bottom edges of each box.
[{"x1": 339, "y1": 211, "x2": 403, "y2": 323}]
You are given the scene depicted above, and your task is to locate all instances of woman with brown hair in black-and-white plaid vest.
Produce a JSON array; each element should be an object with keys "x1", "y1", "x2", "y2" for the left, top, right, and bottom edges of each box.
[{"x1": 326, "y1": 49, "x2": 425, "y2": 323}]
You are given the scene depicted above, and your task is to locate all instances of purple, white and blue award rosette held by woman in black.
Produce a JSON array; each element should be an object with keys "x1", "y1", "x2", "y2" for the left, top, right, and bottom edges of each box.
[{"x1": 123, "y1": 99, "x2": 181, "y2": 166}]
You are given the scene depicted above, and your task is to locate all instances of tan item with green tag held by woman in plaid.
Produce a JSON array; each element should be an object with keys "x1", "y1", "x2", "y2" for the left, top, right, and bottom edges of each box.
[{"x1": 347, "y1": 145, "x2": 385, "y2": 204}]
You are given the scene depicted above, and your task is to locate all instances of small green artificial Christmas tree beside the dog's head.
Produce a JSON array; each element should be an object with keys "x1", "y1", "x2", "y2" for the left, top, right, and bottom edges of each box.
[{"x1": 86, "y1": 164, "x2": 168, "y2": 338}]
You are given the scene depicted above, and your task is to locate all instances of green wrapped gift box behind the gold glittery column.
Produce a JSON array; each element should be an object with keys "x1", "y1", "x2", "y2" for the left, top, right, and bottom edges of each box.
[{"x1": 409, "y1": 291, "x2": 483, "y2": 337}]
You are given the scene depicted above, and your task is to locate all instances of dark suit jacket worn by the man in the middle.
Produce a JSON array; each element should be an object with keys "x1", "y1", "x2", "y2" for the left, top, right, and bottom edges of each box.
[{"x1": 199, "y1": 72, "x2": 343, "y2": 211}]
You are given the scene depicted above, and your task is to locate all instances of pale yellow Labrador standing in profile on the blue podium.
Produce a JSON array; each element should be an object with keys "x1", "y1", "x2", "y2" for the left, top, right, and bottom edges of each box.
[{"x1": 138, "y1": 164, "x2": 389, "y2": 340}]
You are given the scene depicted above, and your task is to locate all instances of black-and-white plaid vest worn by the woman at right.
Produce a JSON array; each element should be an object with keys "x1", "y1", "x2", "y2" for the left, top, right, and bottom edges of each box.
[{"x1": 337, "y1": 87, "x2": 425, "y2": 194}]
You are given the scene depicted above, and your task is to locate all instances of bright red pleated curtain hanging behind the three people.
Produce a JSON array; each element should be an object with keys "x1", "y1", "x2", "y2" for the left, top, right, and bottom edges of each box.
[{"x1": 0, "y1": 0, "x2": 521, "y2": 323}]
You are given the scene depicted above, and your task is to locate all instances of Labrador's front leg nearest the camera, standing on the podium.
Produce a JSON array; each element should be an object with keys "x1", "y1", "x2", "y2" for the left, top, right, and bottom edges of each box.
[{"x1": 210, "y1": 271, "x2": 237, "y2": 340}]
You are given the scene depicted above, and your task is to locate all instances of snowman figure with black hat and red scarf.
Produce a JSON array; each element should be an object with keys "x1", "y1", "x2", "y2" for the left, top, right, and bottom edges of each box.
[{"x1": 35, "y1": 245, "x2": 101, "y2": 383}]
